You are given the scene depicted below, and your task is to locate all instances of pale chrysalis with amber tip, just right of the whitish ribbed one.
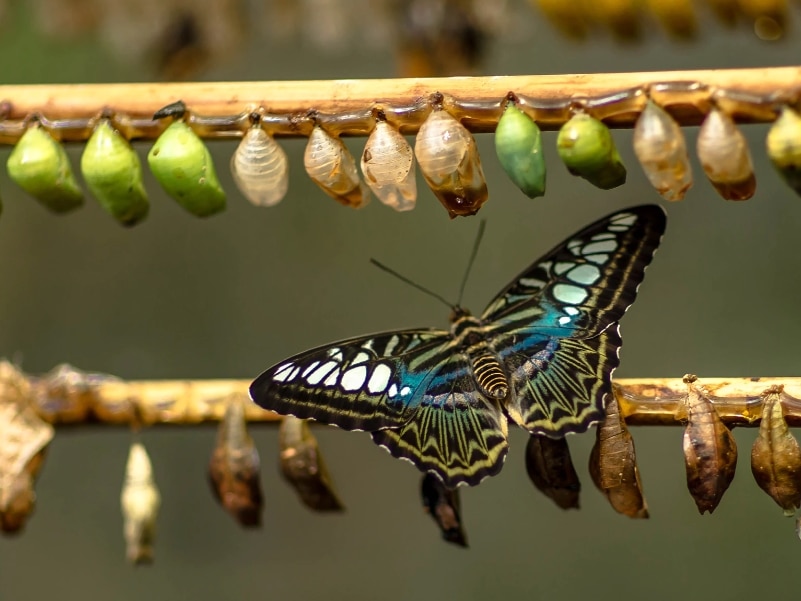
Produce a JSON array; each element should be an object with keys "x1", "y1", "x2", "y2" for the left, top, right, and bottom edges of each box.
[{"x1": 303, "y1": 125, "x2": 370, "y2": 209}]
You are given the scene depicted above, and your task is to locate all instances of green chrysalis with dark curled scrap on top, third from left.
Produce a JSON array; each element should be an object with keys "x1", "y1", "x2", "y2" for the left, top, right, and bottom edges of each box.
[{"x1": 147, "y1": 121, "x2": 225, "y2": 217}]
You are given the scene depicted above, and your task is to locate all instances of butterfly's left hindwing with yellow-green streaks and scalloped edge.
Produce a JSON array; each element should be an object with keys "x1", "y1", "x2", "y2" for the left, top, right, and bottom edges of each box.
[{"x1": 372, "y1": 350, "x2": 507, "y2": 488}]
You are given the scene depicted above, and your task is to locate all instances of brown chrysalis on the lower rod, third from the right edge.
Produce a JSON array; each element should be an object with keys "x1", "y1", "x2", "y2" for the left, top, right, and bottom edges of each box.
[{"x1": 590, "y1": 395, "x2": 648, "y2": 518}]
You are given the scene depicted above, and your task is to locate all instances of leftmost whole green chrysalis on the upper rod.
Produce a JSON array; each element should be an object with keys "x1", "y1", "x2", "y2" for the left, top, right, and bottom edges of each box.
[{"x1": 6, "y1": 122, "x2": 83, "y2": 213}]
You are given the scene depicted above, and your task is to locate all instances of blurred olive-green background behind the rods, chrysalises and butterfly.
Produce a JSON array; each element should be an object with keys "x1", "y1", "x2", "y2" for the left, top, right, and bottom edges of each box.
[{"x1": 0, "y1": 2, "x2": 801, "y2": 601}]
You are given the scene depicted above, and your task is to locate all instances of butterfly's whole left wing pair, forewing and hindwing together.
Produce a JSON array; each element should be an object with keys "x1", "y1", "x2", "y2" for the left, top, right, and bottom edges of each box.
[{"x1": 250, "y1": 330, "x2": 507, "y2": 487}]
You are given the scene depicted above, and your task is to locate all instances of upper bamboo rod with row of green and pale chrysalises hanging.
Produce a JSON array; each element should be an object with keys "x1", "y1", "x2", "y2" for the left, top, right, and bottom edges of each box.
[{"x1": 0, "y1": 66, "x2": 801, "y2": 144}]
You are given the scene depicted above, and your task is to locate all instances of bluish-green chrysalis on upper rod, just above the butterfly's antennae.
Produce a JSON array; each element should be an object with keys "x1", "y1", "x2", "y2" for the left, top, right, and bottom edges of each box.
[{"x1": 495, "y1": 102, "x2": 545, "y2": 198}]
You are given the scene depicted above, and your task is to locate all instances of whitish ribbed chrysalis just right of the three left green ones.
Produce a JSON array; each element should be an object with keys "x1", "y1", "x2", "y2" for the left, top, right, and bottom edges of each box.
[{"x1": 231, "y1": 124, "x2": 289, "y2": 207}]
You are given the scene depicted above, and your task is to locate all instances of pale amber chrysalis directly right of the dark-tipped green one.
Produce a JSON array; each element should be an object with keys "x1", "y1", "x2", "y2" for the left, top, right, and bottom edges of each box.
[{"x1": 634, "y1": 101, "x2": 693, "y2": 200}]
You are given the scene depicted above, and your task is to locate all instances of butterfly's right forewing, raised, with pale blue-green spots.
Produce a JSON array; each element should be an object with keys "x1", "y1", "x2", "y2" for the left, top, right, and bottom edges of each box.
[{"x1": 482, "y1": 205, "x2": 666, "y2": 338}]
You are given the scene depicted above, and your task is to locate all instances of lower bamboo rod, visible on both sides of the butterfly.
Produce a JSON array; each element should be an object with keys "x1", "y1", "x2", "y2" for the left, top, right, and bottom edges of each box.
[{"x1": 0, "y1": 362, "x2": 801, "y2": 426}]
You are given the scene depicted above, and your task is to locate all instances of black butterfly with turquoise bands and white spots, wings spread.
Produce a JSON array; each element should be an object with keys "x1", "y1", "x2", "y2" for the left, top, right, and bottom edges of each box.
[{"x1": 250, "y1": 205, "x2": 666, "y2": 488}]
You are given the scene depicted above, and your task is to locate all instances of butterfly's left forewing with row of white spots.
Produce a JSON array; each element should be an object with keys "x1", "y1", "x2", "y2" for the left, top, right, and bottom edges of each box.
[{"x1": 250, "y1": 329, "x2": 450, "y2": 431}]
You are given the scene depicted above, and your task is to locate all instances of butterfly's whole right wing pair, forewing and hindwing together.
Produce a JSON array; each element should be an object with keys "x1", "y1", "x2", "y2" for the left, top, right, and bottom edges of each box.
[{"x1": 482, "y1": 205, "x2": 666, "y2": 437}]
